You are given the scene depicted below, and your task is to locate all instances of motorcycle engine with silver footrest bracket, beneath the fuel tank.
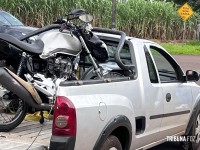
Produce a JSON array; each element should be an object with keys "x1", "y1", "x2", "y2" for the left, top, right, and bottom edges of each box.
[{"x1": 24, "y1": 55, "x2": 76, "y2": 97}]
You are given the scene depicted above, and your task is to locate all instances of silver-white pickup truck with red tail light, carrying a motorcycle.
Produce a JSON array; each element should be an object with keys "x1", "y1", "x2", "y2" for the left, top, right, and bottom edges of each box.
[{"x1": 50, "y1": 30, "x2": 200, "y2": 150}]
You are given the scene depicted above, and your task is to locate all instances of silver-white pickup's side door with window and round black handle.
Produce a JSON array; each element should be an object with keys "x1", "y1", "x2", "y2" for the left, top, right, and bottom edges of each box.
[{"x1": 147, "y1": 43, "x2": 192, "y2": 138}]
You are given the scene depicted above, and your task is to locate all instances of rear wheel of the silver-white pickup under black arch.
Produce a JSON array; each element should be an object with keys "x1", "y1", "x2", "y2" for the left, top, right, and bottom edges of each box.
[{"x1": 101, "y1": 135, "x2": 122, "y2": 150}]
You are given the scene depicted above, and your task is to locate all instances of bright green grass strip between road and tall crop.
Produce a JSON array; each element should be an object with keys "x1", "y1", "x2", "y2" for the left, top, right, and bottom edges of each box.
[{"x1": 161, "y1": 41, "x2": 200, "y2": 55}]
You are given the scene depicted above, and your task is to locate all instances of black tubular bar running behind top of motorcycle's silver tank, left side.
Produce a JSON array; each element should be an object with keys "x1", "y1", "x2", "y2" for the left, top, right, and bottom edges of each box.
[{"x1": 19, "y1": 24, "x2": 61, "y2": 41}]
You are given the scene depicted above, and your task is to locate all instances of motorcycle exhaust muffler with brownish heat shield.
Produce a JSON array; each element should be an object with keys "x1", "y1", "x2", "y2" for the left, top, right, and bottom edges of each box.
[{"x1": 0, "y1": 67, "x2": 53, "y2": 110}]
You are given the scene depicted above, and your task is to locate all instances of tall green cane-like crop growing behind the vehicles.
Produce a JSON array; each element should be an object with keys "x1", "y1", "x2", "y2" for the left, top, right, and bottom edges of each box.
[{"x1": 0, "y1": 0, "x2": 200, "y2": 40}]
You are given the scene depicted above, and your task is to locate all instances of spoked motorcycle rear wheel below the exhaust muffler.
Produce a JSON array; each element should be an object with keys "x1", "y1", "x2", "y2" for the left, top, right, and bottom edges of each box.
[{"x1": 0, "y1": 85, "x2": 27, "y2": 132}]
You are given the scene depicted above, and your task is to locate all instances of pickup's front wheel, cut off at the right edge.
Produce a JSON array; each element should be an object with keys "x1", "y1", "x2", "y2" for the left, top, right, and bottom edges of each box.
[{"x1": 181, "y1": 111, "x2": 200, "y2": 150}]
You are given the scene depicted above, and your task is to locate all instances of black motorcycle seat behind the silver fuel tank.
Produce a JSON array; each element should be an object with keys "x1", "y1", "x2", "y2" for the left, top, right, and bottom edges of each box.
[{"x1": 0, "y1": 33, "x2": 44, "y2": 54}]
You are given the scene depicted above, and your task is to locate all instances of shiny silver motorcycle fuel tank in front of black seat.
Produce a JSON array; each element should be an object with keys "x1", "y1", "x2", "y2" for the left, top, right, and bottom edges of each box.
[{"x1": 38, "y1": 30, "x2": 82, "y2": 59}]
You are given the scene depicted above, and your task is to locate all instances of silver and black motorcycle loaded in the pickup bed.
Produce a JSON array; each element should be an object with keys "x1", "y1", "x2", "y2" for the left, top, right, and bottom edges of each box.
[{"x1": 0, "y1": 9, "x2": 126, "y2": 132}]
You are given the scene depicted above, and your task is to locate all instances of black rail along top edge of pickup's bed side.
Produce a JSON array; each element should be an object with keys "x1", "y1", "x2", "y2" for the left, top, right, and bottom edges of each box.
[{"x1": 59, "y1": 77, "x2": 134, "y2": 86}]
